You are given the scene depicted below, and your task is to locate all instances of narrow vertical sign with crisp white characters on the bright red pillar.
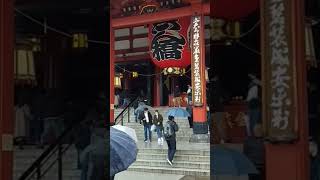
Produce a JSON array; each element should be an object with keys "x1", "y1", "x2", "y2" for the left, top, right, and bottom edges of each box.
[{"x1": 191, "y1": 16, "x2": 203, "y2": 106}]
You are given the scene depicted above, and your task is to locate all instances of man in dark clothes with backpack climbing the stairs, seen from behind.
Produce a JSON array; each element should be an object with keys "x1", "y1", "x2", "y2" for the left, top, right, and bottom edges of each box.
[{"x1": 164, "y1": 116, "x2": 179, "y2": 166}]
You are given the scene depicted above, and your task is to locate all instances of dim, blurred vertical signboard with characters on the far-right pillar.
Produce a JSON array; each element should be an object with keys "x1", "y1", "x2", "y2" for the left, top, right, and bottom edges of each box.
[{"x1": 262, "y1": 0, "x2": 297, "y2": 142}]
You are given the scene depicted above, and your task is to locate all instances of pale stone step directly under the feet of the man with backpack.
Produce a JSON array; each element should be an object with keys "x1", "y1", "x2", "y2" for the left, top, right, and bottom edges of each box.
[{"x1": 132, "y1": 158, "x2": 210, "y2": 170}]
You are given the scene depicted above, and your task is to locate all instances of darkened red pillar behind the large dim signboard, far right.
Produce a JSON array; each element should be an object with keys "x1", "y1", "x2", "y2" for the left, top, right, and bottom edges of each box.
[{"x1": 261, "y1": 0, "x2": 310, "y2": 180}]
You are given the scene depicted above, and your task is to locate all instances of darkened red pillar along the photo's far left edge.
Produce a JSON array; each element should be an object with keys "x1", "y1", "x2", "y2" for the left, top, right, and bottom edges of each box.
[{"x1": 0, "y1": 0, "x2": 14, "y2": 180}]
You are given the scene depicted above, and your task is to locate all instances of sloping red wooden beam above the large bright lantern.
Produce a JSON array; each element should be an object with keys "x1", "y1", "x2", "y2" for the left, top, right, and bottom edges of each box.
[{"x1": 111, "y1": 3, "x2": 210, "y2": 29}]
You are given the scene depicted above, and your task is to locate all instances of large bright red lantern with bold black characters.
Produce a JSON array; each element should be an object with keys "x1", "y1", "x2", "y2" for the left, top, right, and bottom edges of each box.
[{"x1": 149, "y1": 17, "x2": 191, "y2": 68}]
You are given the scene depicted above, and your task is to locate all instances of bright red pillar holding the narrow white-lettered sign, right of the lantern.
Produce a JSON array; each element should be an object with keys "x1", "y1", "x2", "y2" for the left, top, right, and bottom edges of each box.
[{"x1": 190, "y1": 0, "x2": 210, "y2": 142}]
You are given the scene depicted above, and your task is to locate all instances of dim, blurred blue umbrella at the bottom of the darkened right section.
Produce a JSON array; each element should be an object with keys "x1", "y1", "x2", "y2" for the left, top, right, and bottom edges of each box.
[{"x1": 210, "y1": 145, "x2": 258, "y2": 176}]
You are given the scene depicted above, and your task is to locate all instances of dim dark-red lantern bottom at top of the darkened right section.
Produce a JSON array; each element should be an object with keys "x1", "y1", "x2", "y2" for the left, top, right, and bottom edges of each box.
[{"x1": 210, "y1": 0, "x2": 259, "y2": 20}]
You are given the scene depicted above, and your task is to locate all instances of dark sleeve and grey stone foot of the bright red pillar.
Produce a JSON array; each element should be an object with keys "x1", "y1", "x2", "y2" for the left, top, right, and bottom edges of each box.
[{"x1": 189, "y1": 122, "x2": 210, "y2": 143}]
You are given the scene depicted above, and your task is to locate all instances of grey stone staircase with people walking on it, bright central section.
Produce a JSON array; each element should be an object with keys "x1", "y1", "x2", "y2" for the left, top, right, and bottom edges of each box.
[{"x1": 115, "y1": 107, "x2": 210, "y2": 176}]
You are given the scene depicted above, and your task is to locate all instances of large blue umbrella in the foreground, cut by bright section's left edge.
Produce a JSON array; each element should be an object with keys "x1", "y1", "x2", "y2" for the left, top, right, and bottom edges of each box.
[{"x1": 110, "y1": 127, "x2": 138, "y2": 176}]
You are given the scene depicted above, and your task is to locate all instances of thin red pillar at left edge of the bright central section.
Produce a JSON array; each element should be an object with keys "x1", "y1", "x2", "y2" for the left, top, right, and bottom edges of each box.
[{"x1": 109, "y1": 18, "x2": 115, "y2": 125}]
